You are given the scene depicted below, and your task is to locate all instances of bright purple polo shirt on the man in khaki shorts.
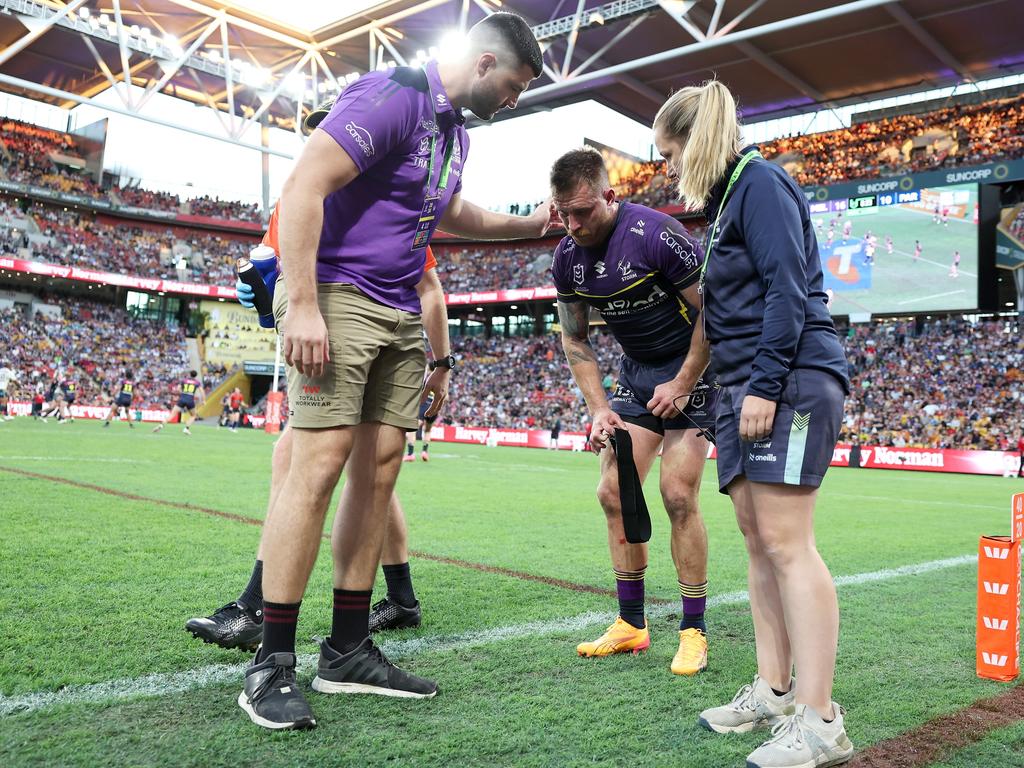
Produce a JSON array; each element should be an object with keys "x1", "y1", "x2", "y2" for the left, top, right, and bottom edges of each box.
[{"x1": 316, "y1": 61, "x2": 469, "y2": 313}]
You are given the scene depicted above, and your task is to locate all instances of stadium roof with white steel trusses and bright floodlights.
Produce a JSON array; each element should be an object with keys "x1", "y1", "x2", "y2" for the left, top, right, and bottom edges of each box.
[{"x1": 0, "y1": 0, "x2": 1024, "y2": 154}]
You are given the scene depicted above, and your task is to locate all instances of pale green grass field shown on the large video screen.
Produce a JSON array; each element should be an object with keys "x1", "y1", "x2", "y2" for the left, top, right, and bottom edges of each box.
[{"x1": 813, "y1": 184, "x2": 978, "y2": 314}]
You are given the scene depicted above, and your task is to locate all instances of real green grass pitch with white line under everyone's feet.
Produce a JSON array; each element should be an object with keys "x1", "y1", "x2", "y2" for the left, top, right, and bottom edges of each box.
[{"x1": 0, "y1": 420, "x2": 1024, "y2": 768}]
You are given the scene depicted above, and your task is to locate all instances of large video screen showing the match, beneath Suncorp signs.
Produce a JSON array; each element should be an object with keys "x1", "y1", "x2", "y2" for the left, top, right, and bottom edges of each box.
[{"x1": 810, "y1": 184, "x2": 978, "y2": 315}]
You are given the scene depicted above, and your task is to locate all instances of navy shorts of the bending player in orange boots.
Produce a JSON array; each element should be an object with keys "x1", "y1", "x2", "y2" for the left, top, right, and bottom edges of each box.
[{"x1": 608, "y1": 354, "x2": 721, "y2": 434}]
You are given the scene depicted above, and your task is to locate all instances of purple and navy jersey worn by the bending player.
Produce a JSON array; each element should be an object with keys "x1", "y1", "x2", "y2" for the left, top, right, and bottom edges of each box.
[{"x1": 551, "y1": 203, "x2": 703, "y2": 362}]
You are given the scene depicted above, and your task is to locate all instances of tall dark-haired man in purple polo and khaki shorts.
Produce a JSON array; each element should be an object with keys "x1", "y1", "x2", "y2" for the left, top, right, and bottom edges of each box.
[{"x1": 239, "y1": 13, "x2": 551, "y2": 729}]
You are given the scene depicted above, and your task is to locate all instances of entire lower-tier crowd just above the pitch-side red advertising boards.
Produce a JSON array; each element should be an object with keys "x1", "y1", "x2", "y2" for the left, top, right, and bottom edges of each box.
[{"x1": 0, "y1": 284, "x2": 1024, "y2": 450}]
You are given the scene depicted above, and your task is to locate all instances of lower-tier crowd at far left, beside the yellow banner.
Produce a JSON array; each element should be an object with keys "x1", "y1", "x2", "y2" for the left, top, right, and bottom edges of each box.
[{"x1": 0, "y1": 296, "x2": 189, "y2": 408}]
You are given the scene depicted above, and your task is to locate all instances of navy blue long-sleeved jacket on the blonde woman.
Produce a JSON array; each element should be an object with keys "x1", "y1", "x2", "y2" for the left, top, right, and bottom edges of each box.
[{"x1": 703, "y1": 146, "x2": 849, "y2": 402}]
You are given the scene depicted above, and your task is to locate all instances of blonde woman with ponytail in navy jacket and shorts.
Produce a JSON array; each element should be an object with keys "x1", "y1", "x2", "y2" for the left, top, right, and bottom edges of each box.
[{"x1": 653, "y1": 80, "x2": 853, "y2": 768}]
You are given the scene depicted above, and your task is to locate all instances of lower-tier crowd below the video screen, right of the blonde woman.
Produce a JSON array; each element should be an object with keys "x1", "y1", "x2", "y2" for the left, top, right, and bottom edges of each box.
[{"x1": 841, "y1": 318, "x2": 1024, "y2": 450}]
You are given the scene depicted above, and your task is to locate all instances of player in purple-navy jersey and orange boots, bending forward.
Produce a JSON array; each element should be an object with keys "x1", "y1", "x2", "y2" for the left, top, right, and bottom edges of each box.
[{"x1": 551, "y1": 150, "x2": 717, "y2": 675}]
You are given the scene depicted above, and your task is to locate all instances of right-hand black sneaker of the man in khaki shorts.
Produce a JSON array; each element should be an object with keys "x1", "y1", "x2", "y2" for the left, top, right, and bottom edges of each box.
[{"x1": 313, "y1": 637, "x2": 437, "y2": 698}]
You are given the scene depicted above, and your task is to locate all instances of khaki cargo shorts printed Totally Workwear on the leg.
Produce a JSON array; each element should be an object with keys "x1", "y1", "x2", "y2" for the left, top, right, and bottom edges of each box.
[{"x1": 273, "y1": 280, "x2": 426, "y2": 430}]
